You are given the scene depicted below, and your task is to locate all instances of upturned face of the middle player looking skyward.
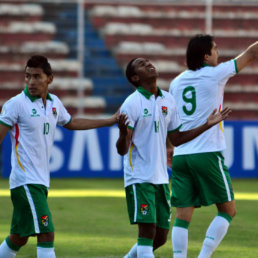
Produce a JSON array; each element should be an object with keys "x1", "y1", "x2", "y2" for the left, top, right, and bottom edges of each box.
[{"x1": 133, "y1": 58, "x2": 158, "y2": 81}]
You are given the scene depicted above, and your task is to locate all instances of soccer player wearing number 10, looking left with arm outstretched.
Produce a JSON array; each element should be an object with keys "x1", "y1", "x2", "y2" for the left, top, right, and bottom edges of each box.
[{"x1": 0, "y1": 56, "x2": 118, "y2": 258}]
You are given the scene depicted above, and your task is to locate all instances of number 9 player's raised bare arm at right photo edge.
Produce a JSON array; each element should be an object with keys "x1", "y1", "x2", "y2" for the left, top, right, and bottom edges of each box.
[{"x1": 235, "y1": 41, "x2": 258, "y2": 72}]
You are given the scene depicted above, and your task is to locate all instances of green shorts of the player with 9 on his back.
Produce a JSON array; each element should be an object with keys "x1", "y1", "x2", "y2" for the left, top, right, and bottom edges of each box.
[{"x1": 171, "y1": 152, "x2": 234, "y2": 207}]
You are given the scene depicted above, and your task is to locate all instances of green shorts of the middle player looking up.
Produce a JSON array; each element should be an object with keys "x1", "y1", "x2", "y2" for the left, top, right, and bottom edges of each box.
[{"x1": 125, "y1": 183, "x2": 171, "y2": 229}]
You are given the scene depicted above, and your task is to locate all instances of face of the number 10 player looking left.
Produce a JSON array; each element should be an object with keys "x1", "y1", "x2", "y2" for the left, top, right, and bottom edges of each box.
[{"x1": 25, "y1": 67, "x2": 53, "y2": 98}]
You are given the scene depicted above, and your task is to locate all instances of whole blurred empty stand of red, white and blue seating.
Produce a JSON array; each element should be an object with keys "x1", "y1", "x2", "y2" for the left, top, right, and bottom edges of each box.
[{"x1": 0, "y1": 0, "x2": 258, "y2": 119}]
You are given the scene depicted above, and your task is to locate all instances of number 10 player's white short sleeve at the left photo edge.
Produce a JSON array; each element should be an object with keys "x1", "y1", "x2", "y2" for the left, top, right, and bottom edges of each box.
[{"x1": 0, "y1": 98, "x2": 19, "y2": 127}]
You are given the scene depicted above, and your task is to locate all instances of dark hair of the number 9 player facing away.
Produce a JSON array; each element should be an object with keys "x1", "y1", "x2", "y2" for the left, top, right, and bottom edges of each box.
[{"x1": 186, "y1": 34, "x2": 214, "y2": 71}]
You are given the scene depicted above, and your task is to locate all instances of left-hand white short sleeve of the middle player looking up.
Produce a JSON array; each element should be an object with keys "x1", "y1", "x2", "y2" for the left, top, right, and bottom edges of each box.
[{"x1": 120, "y1": 95, "x2": 139, "y2": 129}]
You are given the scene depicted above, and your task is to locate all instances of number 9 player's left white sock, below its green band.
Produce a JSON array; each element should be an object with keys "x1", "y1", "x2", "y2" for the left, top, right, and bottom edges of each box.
[{"x1": 171, "y1": 226, "x2": 188, "y2": 258}]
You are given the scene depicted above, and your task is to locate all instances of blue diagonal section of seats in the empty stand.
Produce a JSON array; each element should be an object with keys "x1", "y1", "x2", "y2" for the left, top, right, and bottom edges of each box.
[{"x1": 42, "y1": 3, "x2": 133, "y2": 113}]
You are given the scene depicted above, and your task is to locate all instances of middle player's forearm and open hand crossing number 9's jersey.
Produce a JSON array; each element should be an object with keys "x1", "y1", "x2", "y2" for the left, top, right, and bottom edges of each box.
[{"x1": 168, "y1": 107, "x2": 231, "y2": 146}]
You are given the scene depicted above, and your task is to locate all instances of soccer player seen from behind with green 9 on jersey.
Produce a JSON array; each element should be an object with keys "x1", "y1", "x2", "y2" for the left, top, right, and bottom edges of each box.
[{"x1": 169, "y1": 35, "x2": 258, "y2": 258}]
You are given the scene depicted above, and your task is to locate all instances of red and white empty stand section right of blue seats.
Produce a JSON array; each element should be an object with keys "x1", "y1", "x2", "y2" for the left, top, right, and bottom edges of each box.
[{"x1": 86, "y1": 2, "x2": 258, "y2": 119}]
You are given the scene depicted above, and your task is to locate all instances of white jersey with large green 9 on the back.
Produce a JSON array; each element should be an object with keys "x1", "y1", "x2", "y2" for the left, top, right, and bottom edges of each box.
[{"x1": 169, "y1": 60, "x2": 237, "y2": 156}]
